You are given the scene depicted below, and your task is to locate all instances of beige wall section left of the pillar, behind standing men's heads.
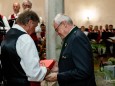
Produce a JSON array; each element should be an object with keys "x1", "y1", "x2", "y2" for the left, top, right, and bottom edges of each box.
[{"x1": 0, "y1": 0, "x2": 44, "y2": 18}]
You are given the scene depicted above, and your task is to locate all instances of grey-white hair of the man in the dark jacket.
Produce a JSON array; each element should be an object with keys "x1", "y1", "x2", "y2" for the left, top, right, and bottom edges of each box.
[{"x1": 54, "y1": 13, "x2": 73, "y2": 24}]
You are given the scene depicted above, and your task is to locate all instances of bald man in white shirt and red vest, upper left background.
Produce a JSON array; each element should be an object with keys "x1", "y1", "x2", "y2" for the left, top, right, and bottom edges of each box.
[{"x1": 8, "y1": 2, "x2": 20, "y2": 27}]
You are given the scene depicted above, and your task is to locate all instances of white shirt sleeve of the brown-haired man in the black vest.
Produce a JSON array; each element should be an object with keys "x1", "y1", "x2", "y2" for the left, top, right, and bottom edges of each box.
[{"x1": 16, "y1": 34, "x2": 47, "y2": 81}]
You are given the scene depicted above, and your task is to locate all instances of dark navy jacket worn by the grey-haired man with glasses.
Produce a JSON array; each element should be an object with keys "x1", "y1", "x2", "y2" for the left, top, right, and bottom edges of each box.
[{"x1": 57, "y1": 27, "x2": 96, "y2": 86}]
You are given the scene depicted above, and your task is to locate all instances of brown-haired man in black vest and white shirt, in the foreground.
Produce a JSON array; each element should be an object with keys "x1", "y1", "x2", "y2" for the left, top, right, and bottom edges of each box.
[{"x1": 1, "y1": 10, "x2": 49, "y2": 86}]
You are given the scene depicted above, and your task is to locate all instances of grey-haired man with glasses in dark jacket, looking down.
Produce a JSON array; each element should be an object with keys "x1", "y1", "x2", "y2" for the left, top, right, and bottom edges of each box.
[{"x1": 45, "y1": 14, "x2": 96, "y2": 86}]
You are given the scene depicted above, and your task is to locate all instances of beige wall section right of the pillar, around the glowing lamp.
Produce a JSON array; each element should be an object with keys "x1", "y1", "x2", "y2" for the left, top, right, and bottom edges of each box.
[{"x1": 65, "y1": 0, "x2": 115, "y2": 27}]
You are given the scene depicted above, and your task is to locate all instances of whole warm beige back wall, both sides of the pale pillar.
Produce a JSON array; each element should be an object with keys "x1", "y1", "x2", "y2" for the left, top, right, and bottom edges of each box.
[{"x1": 0, "y1": 0, "x2": 115, "y2": 27}]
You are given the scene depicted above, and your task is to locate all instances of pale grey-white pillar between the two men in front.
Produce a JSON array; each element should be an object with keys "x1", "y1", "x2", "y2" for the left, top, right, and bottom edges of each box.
[{"x1": 45, "y1": 0, "x2": 64, "y2": 60}]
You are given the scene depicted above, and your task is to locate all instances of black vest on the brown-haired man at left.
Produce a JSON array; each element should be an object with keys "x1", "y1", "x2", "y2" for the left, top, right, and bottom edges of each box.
[{"x1": 1, "y1": 28, "x2": 27, "y2": 80}]
